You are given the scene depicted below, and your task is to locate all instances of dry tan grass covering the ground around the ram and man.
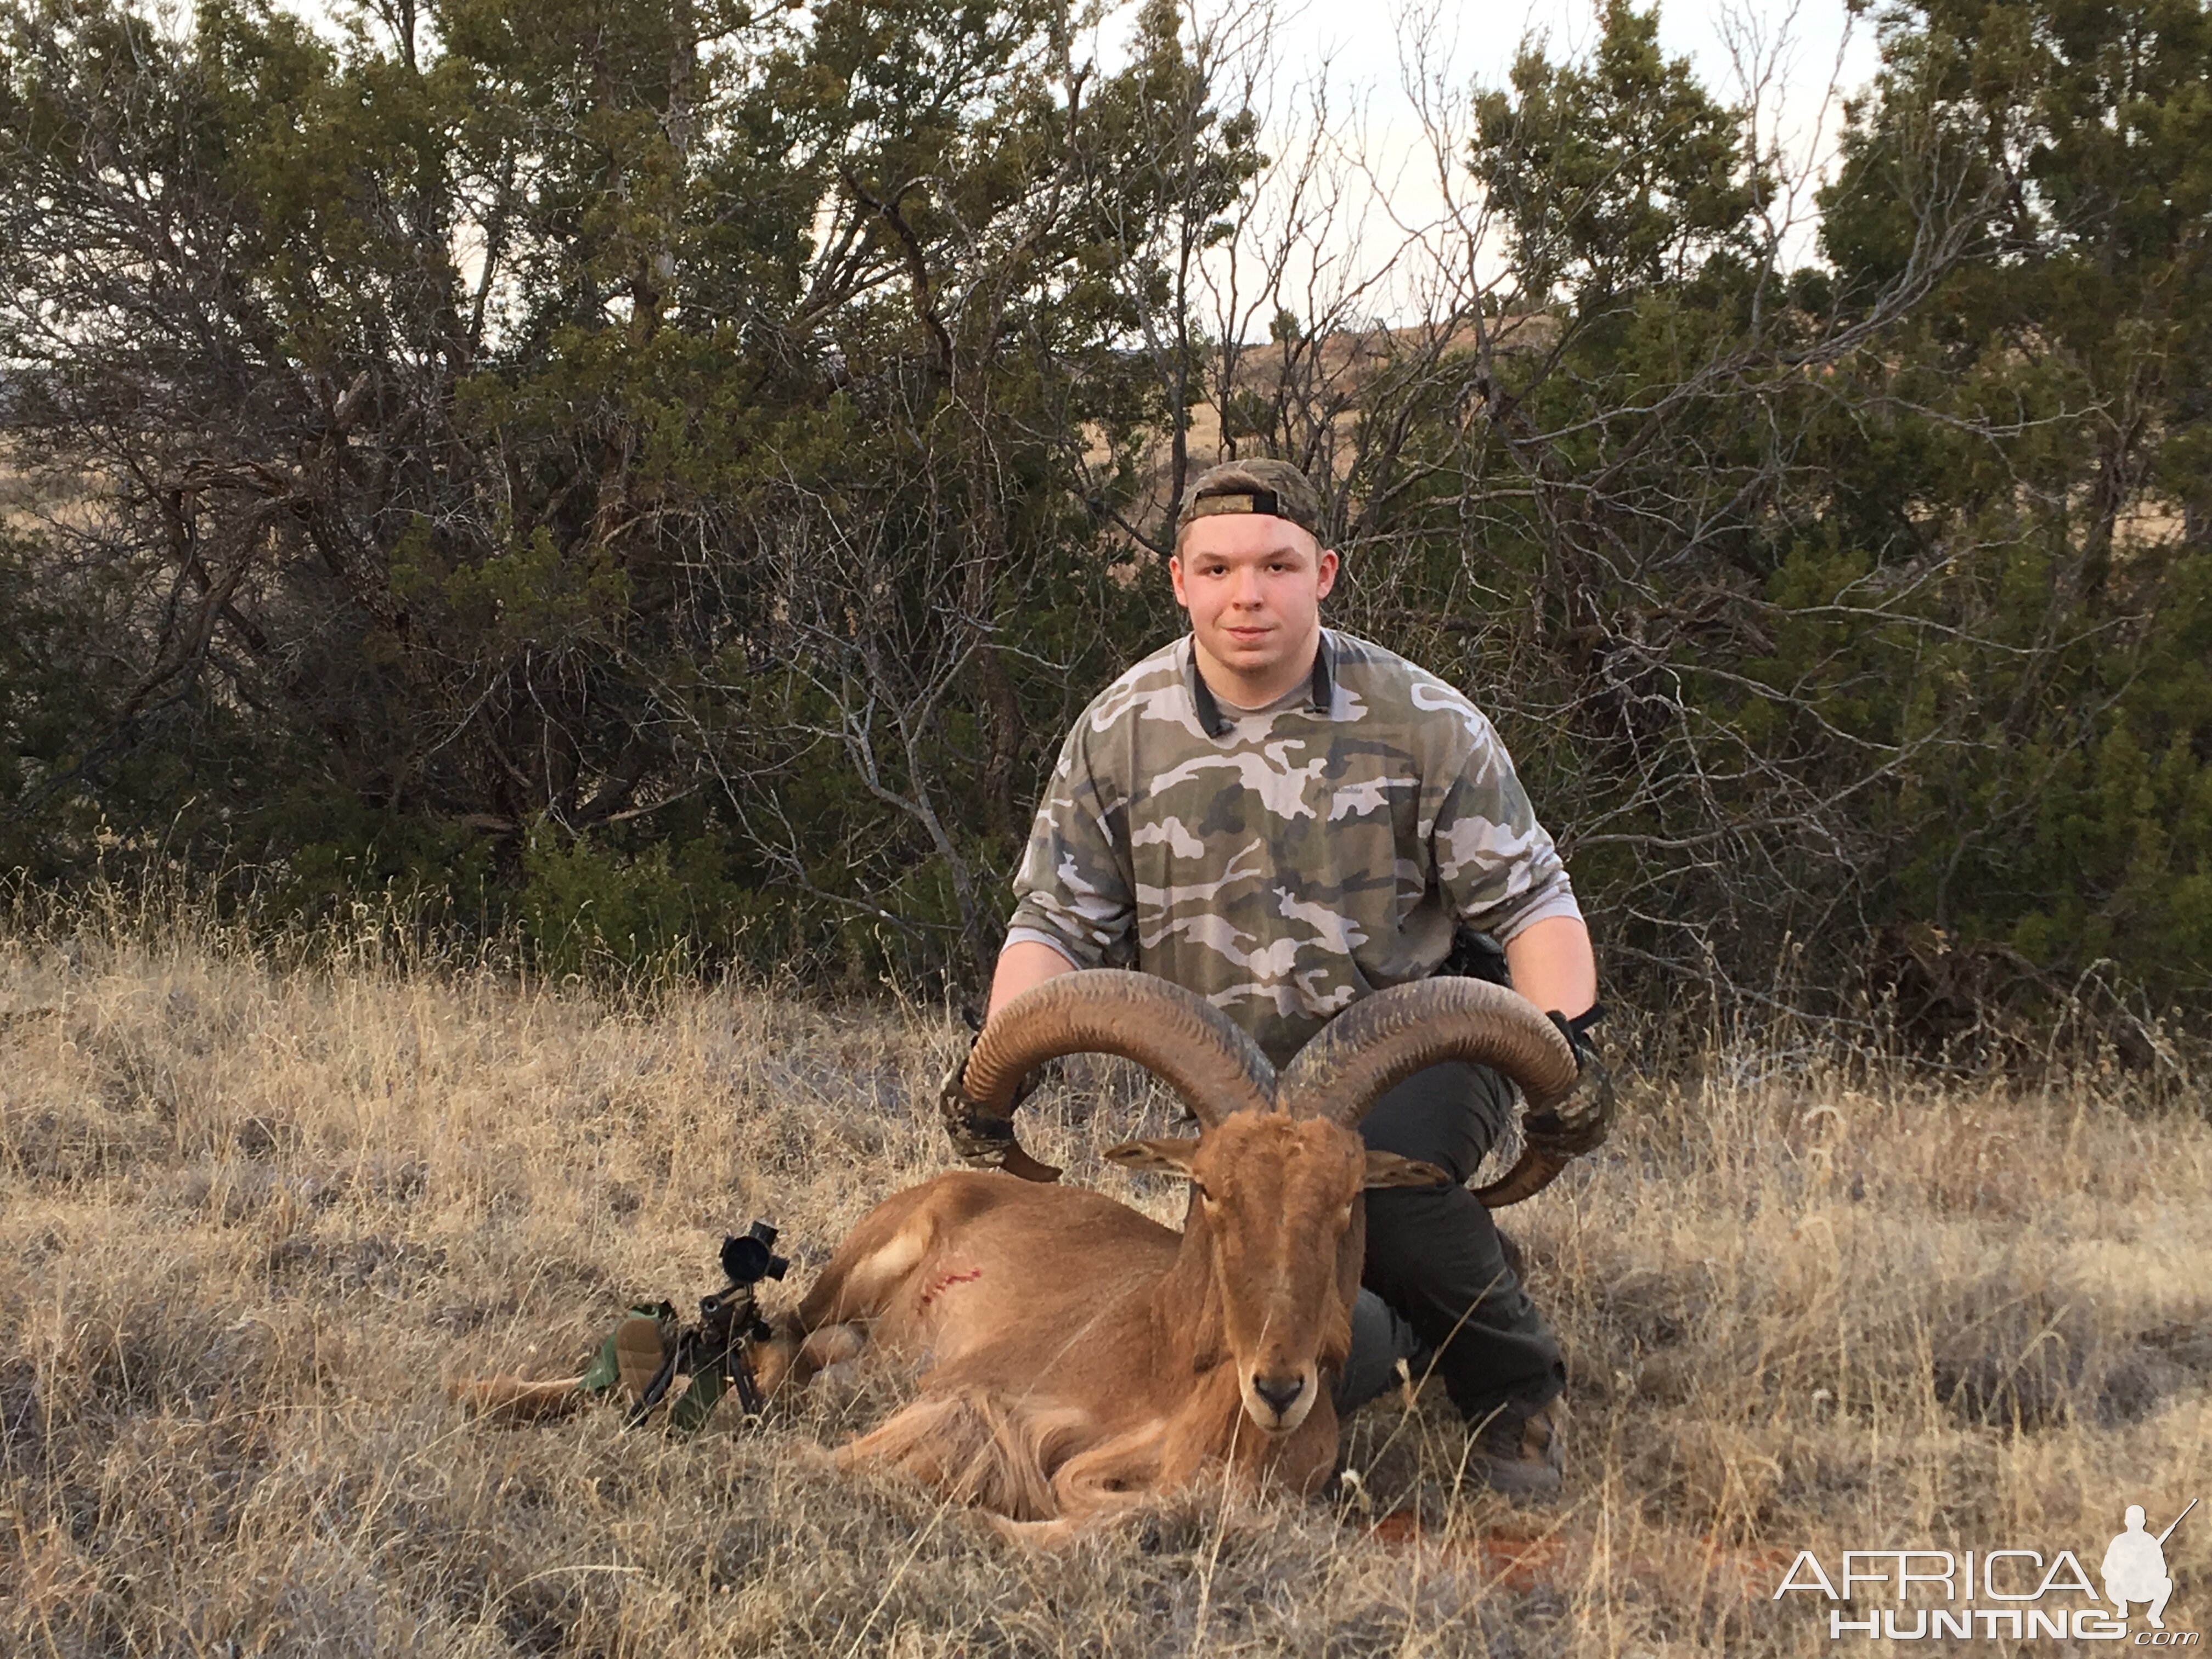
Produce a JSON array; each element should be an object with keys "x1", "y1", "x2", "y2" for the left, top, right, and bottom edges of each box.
[{"x1": 0, "y1": 902, "x2": 2212, "y2": 1657}]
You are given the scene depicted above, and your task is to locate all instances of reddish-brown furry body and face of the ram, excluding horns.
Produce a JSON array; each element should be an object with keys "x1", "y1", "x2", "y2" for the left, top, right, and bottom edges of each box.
[{"x1": 757, "y1": 1113, "x2": 1442, "y2": 1539}]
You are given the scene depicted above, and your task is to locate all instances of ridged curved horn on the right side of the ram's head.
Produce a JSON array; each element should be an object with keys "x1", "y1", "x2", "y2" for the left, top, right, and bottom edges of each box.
[{"x1": 1276, "y1": 978, "x2": 1577, "y2": 1210}]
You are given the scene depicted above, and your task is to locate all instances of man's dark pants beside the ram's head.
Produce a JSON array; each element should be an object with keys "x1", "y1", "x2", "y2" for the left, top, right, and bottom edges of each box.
[{"x1": 1361, "y1": 1062, "x2": 1566, "y2": 1423}]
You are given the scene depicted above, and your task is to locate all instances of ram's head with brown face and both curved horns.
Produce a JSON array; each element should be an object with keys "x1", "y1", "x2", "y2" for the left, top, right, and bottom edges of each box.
[{"x1": 962, "y1": 969, "x2": 1575, "y2": 1434}]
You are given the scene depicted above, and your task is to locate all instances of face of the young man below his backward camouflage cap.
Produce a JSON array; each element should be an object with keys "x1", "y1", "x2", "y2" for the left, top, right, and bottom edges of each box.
[{"x1": 1168, "y1": 513, "x2": 1336, "y2": 681}]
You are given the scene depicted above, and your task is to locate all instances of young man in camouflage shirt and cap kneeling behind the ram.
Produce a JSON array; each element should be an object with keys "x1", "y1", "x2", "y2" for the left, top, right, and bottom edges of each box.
[{"x1": 971, "y1": 460, "x2": 1597, "y2": 1493}]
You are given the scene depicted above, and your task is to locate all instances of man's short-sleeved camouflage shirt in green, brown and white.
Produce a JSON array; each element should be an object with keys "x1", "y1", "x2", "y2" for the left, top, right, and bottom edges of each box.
[{"x1": 1007, "y1": 628, "x2": 1582, "y2": 1064}]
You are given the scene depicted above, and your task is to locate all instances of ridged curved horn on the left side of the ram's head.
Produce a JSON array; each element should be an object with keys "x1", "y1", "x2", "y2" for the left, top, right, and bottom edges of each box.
[{"x1": 960, "y1": 969, "x2": 1274, "y2": 1128}]
